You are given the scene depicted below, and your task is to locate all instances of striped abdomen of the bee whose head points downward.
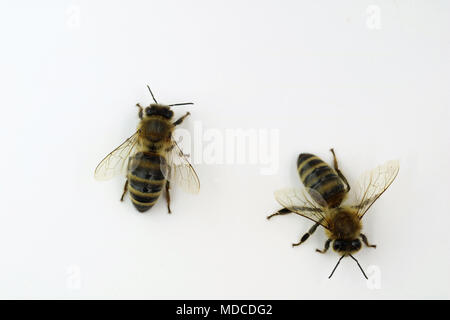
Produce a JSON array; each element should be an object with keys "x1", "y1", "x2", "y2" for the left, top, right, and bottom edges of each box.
[{"x1": 297, "y1": 153, "x2": 348, "y2": 208}]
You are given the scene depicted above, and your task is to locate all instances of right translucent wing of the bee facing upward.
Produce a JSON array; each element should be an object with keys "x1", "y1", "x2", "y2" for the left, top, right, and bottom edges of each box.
[{"x1": 163, "y1": 140, "x2": 200, "y2": 193}]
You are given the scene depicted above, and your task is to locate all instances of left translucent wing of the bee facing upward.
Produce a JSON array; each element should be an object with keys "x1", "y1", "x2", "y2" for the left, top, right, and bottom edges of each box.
[{"x1": 94, "y1": 132, "x2": 138, "y2": 180}]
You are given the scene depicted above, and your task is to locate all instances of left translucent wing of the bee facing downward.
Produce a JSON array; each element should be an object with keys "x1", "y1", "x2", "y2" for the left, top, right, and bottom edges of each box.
[{"x1": 275, "y1": 188, "x2": 328, "y2": 229}]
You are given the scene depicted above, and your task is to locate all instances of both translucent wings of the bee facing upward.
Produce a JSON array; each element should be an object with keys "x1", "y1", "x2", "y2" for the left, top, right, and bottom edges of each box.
[{"x1": 94, "y1": 132, "x2": 200, "y2": 193}]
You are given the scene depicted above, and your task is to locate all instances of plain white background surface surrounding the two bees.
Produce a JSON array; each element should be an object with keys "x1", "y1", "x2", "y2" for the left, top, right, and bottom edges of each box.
[{"x1": 0, "y1": 0, "x2": 450, "y2": 299}]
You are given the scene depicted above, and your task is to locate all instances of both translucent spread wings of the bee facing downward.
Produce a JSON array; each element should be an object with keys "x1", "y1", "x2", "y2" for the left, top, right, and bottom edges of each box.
[{"x1": 275, "y1": 161, "x2": 400, "y2": 228}]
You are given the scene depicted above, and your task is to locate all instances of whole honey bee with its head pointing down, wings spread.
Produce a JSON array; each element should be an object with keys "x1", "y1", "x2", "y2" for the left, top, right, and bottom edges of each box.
[{"x1": 267, "y1": 149, "x2": 399, "y2": 279}]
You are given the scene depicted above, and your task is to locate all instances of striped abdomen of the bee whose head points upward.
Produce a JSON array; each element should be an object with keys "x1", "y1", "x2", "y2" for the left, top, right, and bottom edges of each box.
[{"x1": 128, "y1": 152, "x2": 167, "y2": 212}]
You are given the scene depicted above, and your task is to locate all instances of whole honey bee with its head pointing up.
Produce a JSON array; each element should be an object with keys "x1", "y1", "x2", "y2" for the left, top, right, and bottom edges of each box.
[{"x1": 94, "y1": 86, "x2": 200, "y2": 213}]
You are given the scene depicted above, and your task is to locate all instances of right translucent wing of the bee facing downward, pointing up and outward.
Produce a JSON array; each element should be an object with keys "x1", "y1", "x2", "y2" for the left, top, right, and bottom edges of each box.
[{"x1": 353, "y1": 160, "x2": 400, "y2": 219}]
